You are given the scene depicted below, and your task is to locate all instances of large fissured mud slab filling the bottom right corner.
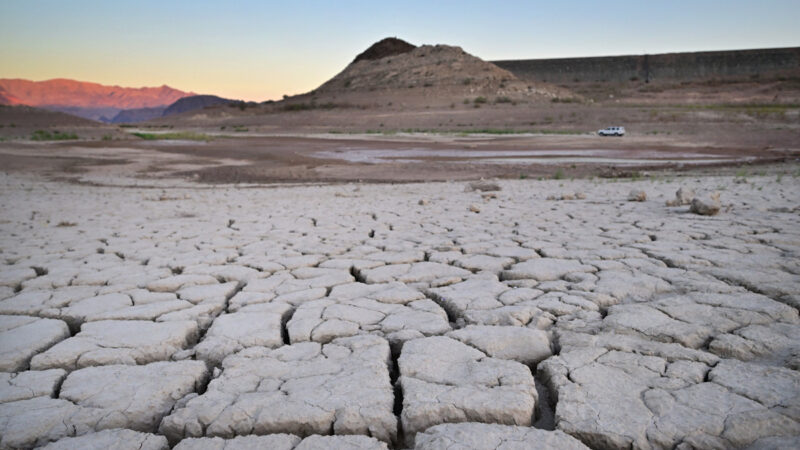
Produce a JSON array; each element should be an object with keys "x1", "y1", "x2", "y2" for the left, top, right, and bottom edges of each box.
[{"x1": 538, "y1": 332, "x2": 800, "y2": 448}]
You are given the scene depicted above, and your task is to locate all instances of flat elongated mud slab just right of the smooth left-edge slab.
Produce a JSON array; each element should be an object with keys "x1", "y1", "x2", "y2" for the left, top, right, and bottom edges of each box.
[{"x1": 31, "y1": 320, "x2": 198, "y2": 370}]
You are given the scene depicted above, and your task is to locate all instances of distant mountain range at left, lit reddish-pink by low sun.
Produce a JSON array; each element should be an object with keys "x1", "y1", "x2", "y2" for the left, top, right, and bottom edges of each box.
[{"x1": 0, "y1": 78, "x2": 233, "y2": 123}]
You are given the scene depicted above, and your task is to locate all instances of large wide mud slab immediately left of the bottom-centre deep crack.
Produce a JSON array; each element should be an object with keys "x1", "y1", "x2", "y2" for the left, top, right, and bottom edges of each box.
[{"x1": 160, "y1": 336, "x2": 397, "y2": 442}]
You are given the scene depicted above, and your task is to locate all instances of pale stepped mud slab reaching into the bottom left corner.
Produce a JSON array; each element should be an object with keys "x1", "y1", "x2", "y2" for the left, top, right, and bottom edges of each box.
[{"x1": 0, "y1": 361, "x2": 207, "y2": 448}]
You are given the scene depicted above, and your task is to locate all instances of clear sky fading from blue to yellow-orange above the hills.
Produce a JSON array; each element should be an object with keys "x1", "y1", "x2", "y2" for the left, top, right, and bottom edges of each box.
[{"x1": 0, "y1": 0, "x2": 800, "y2": 101}]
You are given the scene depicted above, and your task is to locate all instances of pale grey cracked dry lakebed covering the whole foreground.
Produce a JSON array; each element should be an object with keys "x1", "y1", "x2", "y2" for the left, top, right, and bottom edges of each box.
[{"x1": 0, "y1": 169, "x2": 800, "y2": 450}]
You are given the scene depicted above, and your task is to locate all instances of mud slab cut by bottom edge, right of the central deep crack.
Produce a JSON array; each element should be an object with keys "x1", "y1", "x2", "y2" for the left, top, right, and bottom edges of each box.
[{"x1": 414, "y1": 422, "x2": 589, "y2": 450}]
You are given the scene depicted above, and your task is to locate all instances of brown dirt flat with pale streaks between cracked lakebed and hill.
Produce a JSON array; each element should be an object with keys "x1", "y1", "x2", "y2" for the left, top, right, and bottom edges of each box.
[{"x1": 0, "y1": 133, "x2": 800, "y2": 183}]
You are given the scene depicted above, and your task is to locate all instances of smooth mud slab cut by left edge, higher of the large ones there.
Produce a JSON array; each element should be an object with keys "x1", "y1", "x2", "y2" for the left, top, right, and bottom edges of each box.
[{"x1": 0, "y1": 316, "x2": 69, "y2": 372}]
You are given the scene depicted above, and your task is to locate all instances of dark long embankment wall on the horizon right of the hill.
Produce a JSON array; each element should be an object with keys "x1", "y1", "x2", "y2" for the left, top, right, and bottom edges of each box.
[{"x1": 492, "y1": 47, "x2": 800, "y2": 83}]
